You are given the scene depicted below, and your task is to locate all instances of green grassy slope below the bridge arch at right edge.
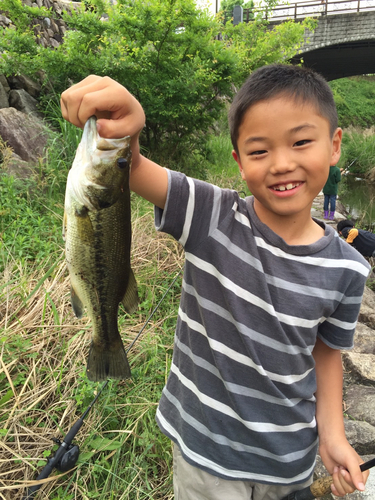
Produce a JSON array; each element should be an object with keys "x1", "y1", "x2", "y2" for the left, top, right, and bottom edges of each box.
[{"x1": 330, "y1": 76, "x2": 375, "y2": 128}]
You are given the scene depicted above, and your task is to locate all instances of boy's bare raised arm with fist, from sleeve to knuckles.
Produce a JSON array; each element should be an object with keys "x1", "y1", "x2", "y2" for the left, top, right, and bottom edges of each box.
[{"x1": 61, "y1": 75, "x2": 168, "y2": 208}]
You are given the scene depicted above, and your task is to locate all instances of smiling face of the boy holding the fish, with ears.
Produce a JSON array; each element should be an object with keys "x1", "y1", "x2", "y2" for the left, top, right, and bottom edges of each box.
[{"x1": 232, "y1": 96, "x2": 342, "y2": 225}]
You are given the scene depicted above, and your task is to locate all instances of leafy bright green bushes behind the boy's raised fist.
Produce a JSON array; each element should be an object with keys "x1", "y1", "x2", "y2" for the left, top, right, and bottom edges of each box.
[{"x1": 0, "y1": 0, "x2": 312, "y2": 171}]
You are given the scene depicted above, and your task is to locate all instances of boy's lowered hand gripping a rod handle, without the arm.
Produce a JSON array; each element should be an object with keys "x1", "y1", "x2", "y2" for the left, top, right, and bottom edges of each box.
[{"x1": 319, "y1": 439, "x2": 369, "y2": 497}]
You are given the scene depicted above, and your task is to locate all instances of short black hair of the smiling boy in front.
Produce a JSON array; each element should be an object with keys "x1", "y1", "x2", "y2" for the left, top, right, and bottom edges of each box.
[{"x1": 228, "y1": 64, "x2": 338, "y2": 154}]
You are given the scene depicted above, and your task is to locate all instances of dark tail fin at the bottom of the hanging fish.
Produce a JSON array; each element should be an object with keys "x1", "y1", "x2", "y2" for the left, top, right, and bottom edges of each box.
[{"x1": 87, "y1": 339, "x2": 131, "y2": 382}]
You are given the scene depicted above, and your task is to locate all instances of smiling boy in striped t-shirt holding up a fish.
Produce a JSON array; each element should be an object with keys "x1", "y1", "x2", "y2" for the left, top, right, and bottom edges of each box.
[{"x1": 61, "y1": 65, "x2": 369, "y2": 500}]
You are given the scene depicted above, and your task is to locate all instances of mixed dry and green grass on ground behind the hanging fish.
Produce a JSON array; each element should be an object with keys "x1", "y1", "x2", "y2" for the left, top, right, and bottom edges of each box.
[{"x1": 0, "y1": 197, "x2": 183, "y2": 500}]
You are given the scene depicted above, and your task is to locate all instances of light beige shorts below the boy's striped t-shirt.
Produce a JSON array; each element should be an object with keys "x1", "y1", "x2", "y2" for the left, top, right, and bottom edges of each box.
[{"x1": 173, "y1": 445, "x2": 312, "y2": 500}]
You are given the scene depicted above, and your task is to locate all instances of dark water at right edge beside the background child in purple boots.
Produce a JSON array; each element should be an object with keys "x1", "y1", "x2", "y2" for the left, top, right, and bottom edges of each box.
[{"x1": 339, "y1": 175, "x2": 375, "y2": 230}]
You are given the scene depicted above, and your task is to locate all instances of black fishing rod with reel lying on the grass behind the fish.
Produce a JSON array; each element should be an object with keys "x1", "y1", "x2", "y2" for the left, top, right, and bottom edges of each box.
[{"x1": 22, "y1": 268, "x2": 182, "y2": 500}]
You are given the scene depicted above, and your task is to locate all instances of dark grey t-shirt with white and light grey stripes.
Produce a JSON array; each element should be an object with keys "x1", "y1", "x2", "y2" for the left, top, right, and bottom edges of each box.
[{"x1": 155, "y1": 171, "x2": 369, "y2": 484}]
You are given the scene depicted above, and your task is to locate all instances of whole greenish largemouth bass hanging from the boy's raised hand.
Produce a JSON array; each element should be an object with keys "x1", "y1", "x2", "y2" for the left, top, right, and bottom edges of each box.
[{"x1": 63, "y1": 116, "x2": 138, "y2": 382}]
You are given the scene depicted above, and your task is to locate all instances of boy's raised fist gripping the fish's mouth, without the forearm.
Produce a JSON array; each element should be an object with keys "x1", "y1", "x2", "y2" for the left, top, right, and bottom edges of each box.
[{"x1": 61, "y1": 75, "x2": 145, "y2": 138}]
